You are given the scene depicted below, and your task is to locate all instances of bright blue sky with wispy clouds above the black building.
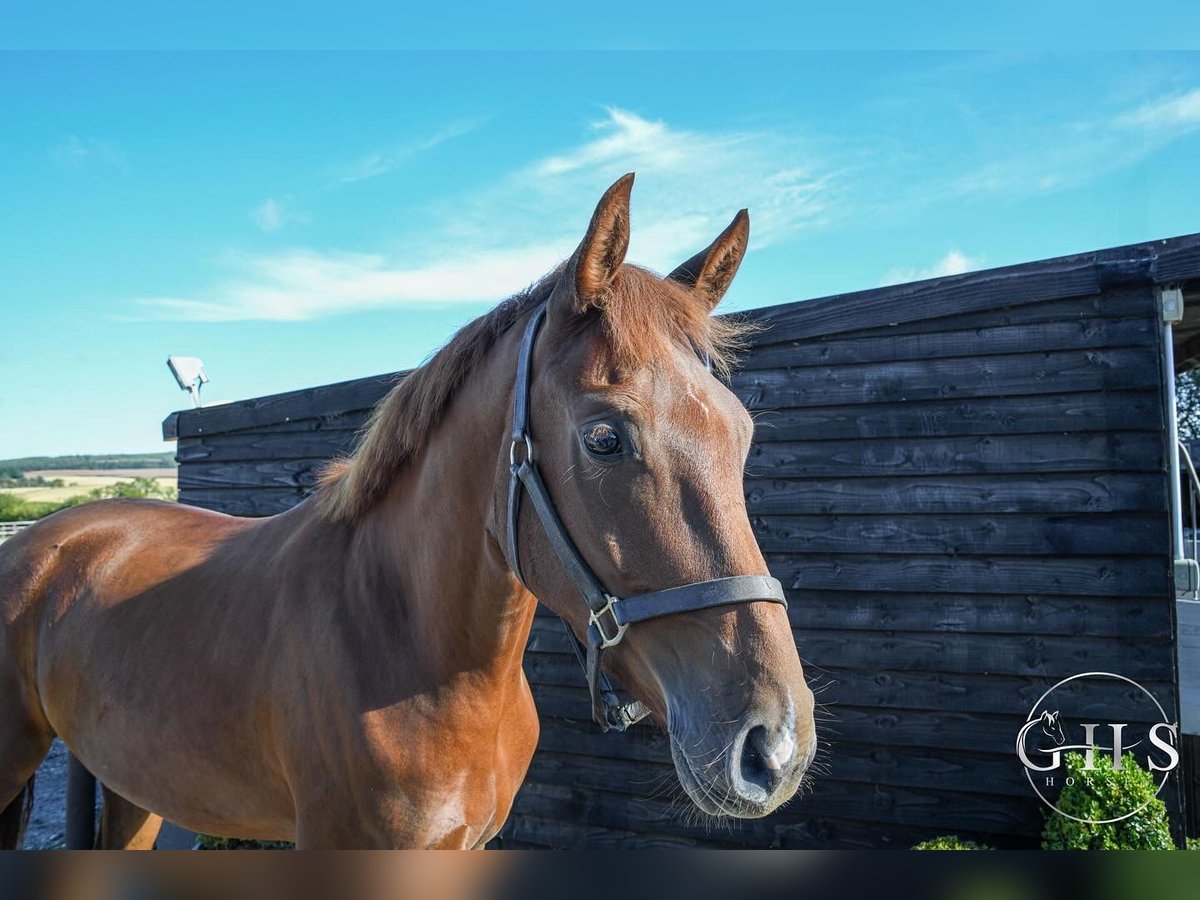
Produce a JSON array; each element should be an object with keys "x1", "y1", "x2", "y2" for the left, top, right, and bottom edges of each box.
[{"x1": 0, "y1": 50, "x2": 1200, "y2": 458}]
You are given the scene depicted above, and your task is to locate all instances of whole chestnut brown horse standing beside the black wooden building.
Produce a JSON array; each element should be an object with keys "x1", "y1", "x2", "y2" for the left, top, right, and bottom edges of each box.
[{"x1": 0, "y1": 175, "x2": 815, "y2": 847}]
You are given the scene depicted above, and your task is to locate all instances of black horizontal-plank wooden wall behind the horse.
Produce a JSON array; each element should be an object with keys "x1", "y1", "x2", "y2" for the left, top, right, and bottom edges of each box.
[{"x1": 166, "y1": 239, "x2": 1200, "y2": 847}]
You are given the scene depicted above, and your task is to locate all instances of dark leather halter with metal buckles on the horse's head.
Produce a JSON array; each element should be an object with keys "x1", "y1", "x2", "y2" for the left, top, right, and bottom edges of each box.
[{"x1": 505, "y1": 302, "x2": 787, "y2": 731}]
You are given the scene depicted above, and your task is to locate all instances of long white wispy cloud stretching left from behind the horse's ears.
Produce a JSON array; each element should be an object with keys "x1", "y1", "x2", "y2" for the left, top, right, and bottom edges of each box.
[{"x1": 140, "y1": 109, "x2": 838, "y2": 322}]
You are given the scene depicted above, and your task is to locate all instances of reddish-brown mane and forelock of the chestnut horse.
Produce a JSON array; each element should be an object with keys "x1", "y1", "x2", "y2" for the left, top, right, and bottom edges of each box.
[{"x1": 314, "y1": 264, "x2": 749, "y2": 522}]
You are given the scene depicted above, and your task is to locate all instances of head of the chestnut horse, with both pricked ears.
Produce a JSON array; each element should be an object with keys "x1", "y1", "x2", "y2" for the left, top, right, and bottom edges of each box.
[{"x1": 506, "y1": 175, "x2": 816, "y2": 817}]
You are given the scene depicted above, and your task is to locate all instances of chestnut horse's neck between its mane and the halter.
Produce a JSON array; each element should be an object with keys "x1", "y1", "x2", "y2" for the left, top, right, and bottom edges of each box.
[{"x1": 355, "y1": 329, "x2": 536, "y2": 674}]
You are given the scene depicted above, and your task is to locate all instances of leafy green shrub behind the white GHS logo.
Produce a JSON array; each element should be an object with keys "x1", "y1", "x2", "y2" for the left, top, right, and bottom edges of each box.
[{"x1": 1042, "y1": 752, "x2": 1175, "y2": 850}]
